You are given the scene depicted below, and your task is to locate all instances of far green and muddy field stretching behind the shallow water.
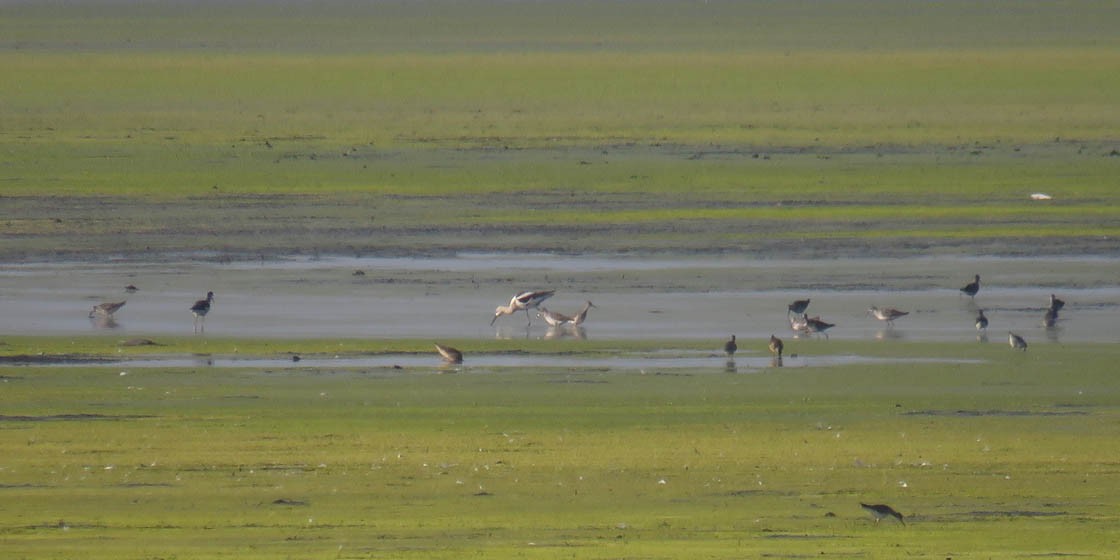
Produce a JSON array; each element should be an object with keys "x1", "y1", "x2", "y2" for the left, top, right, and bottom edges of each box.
[{"x1": 0, "y1": 2, "x2": 1120, "y2": 259}]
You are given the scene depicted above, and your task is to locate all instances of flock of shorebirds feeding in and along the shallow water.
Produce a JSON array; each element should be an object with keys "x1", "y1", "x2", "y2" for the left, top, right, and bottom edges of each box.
[{"x1": 90, "y1": 274, "x2": 1065, "y2": 364}]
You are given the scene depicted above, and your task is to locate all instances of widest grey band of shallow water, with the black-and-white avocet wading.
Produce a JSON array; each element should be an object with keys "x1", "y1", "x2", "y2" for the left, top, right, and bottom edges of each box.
[{"x1": 0, "y1": 254, "x2": 1120, "y2": 348}]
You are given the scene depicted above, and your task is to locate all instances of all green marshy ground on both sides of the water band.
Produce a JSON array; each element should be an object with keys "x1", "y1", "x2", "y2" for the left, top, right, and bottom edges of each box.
[{"x1": 0, "y1": 0, "x2": 1120, "y2": 560}]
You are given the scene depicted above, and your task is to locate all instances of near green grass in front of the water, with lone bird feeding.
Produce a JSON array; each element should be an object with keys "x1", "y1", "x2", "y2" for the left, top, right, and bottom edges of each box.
[{"x1": 0, "y1": 338, "x2": 1120, "y2": 559}]
